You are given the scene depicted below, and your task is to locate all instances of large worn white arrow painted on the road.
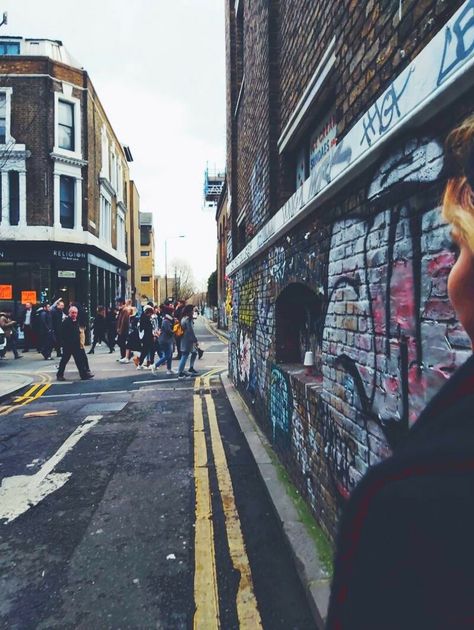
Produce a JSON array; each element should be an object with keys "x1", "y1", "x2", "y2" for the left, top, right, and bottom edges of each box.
[{"x1": 0, "y1": 416, "x2": 102, "y2": 524}]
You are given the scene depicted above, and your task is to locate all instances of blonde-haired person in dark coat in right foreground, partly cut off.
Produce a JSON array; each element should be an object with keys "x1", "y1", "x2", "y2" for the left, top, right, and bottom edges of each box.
[{"x1": 327, "y1": 116, "x2": 474, "y2": 630}]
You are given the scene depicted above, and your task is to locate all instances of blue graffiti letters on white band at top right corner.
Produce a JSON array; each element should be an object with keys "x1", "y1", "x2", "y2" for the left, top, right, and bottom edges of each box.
[{"x1": 437, "y1": 0, "x2": 474, "y2": 85}]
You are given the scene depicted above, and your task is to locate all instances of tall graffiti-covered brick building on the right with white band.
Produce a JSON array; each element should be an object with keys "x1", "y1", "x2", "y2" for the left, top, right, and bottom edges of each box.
[{"x1": 226, "y1": 0, "x2": 474, "y2": 537}]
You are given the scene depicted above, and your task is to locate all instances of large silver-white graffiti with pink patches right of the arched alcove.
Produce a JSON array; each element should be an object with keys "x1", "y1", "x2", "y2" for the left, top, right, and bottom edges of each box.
[{"x1": 321, "y1": 140, "x2": 467, "y2": 496}]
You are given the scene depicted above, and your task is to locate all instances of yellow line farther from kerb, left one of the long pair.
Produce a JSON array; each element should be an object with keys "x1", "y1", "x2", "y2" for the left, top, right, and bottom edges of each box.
[{"x1": 194, "y1": 388, "x2": 220, "y2": 630}]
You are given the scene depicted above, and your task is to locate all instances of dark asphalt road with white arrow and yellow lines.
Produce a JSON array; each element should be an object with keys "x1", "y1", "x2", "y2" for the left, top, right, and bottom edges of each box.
[{"x1": 0, "y1": 319, "x2": 315, "y2": 630}]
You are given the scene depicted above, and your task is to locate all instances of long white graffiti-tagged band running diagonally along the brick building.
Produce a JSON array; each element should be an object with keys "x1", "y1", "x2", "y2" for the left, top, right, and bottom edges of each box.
[{"x1": 227, "y1": 0, "x2": 474, "y2": 274}]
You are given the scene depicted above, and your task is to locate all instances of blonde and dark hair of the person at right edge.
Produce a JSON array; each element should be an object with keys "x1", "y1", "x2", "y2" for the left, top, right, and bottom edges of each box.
[{"x1": 443, "y1": 115, "x2": 474, "y2": 254}]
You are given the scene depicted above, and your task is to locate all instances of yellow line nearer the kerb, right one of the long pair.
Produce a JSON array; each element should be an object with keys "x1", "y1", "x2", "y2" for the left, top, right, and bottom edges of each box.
[{"x1": 204, "y1": 376, "x2": 262, "y2": 630}]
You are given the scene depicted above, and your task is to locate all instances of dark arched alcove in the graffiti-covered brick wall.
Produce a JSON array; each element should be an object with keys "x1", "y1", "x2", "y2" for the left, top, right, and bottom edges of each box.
[{"x1": 275, "y1": 282, "x2": 322, "y2": 364}]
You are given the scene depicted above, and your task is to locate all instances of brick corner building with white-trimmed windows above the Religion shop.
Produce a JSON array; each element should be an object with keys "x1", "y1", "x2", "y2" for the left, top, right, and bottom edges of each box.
[{"x1": 0, "y1": 37, "x2": 131, "y2": 312}]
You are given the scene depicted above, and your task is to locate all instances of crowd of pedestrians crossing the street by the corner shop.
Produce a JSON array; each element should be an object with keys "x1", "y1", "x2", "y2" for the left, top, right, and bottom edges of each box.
[{"x1": 0, "y1": 299, "x2": 203, "y2": 381}]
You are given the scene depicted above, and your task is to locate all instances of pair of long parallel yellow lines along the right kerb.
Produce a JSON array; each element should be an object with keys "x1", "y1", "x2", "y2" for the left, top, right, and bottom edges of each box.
[{"x1": 194, "y1": 368, "x2": 262, "y2": 630}]
